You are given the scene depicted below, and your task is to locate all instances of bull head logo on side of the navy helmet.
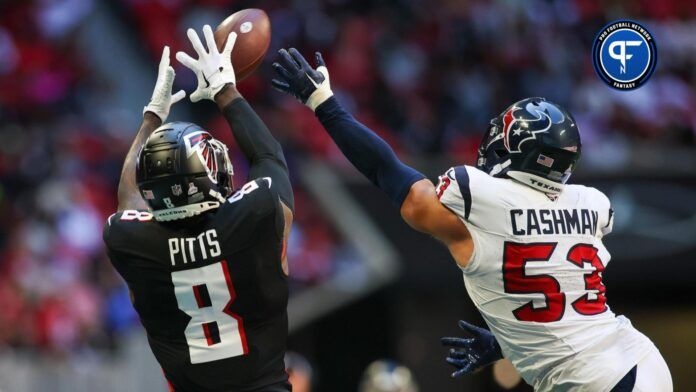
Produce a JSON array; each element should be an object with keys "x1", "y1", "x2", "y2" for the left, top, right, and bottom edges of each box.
[{"x1": 503, "y1": 101, "x2": 565, "y2": 152}]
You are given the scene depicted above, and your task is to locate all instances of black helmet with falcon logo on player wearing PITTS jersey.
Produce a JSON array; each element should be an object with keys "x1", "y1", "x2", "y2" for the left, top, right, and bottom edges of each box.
[{"x1": 136, "y1": 122, "x2": 234, "y2": 221}]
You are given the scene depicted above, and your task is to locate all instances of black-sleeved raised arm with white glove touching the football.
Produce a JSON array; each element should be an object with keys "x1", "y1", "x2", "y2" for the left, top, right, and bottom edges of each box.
[{"x1": 176, "y1": 25, "x2": 294, "y2": 210}]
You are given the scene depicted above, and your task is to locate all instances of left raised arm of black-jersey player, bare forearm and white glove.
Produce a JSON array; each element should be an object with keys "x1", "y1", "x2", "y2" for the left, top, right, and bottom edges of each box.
[{"x1": 118, "y1": 46, "x2": 186, "y2": 212}]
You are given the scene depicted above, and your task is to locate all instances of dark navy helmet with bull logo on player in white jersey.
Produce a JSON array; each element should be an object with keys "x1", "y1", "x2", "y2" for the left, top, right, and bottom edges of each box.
[{"x1": 476, "y1": 97, "x2": 581, "y2": 193}]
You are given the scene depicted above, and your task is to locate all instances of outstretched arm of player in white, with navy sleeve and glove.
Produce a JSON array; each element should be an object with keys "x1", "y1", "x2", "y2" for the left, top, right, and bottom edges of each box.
[{"x1": 273, "y1": 49, "x2": 471, "y2": 251}]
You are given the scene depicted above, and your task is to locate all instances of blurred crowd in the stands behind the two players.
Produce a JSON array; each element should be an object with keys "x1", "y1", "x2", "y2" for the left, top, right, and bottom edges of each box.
[{"x1": 0, "y1": 0, "x2": 696, "y2": 364}]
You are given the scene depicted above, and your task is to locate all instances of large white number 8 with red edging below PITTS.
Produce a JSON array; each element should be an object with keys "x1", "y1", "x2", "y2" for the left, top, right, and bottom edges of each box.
[{"x1": 172, "y1": 260, "x2": 249, "y2": 364}]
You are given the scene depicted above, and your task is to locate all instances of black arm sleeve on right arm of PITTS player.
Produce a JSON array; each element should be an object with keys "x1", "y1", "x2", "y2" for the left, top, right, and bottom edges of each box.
[{"x1": 222, "y1": 97, "x2": 295, "y2": 211}]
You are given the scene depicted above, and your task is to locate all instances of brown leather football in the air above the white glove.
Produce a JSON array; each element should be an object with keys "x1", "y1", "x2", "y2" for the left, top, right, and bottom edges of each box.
[{"x1": 215, "y1": 8, "x2": 271, "y2": 82}]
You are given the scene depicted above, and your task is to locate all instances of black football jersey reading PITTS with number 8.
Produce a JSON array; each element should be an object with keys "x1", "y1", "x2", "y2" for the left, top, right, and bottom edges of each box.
[{"x1": 104, "y1": 178, "x2": 290, "y2": 391}]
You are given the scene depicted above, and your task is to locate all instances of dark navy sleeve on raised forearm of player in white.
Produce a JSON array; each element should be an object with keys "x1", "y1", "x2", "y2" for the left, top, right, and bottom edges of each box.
[{"x1": 316, "y1": 97, "x2": 425, "y2": 207}]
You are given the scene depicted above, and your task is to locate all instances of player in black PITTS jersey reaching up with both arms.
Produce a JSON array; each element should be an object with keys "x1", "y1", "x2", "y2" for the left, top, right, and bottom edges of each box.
[{"x1": 104, "y1": 26, "x2": 293, "y2": 392}]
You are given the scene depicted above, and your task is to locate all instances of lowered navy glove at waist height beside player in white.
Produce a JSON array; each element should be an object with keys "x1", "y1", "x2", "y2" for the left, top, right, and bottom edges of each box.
[{"x1": 441, "y1": 320, "x2": 503, "y2": 377}]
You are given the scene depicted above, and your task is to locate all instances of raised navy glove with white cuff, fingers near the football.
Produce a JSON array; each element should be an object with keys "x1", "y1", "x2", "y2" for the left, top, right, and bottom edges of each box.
[{"x1": 271, "y1": 48, "x2": 333, "y2": 110}]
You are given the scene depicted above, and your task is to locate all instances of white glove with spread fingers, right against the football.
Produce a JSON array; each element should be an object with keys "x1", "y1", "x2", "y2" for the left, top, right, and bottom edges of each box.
[{"x1": 176, "y1": 25, "x2": 237, "y2": 102}]
